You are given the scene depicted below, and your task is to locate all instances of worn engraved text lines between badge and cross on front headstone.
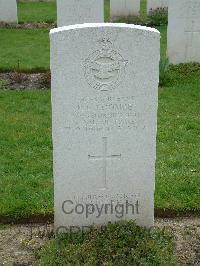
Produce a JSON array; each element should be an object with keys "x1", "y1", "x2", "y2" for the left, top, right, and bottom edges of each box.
[{"x1": 64, "y1": 96, "x2": 148, "y2": 132}]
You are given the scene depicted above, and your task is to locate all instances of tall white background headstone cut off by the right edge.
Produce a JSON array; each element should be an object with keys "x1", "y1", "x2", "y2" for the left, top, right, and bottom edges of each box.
[{"x1": 168, "y1": 0, "x2": 200, "y2": 64}]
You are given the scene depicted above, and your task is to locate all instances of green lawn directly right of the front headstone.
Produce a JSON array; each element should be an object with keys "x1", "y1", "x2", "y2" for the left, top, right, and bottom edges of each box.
[{"x1": 155, "y1": 82, "x2": 200, "y2": 214}]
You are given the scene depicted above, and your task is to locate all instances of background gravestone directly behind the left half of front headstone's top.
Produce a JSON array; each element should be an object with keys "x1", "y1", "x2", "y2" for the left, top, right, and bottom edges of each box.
[{"x1": 57, "y1": 0, "x2": 104, "y2": 27}]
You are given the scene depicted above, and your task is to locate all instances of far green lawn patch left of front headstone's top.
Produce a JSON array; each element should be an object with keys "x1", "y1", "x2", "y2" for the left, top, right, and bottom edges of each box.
[{"x1": 0, "y1": 29, "x2": 50, "y2": 71}]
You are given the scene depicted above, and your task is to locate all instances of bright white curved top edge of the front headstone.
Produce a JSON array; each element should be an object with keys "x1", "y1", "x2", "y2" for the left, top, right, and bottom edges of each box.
[{"x1": 50, "y1": 23, "x2": 160, "y2": 35}]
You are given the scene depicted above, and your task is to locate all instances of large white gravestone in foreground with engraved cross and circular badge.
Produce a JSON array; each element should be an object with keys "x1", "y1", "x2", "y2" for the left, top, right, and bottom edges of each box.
[{"x1": 50, "y1": 23, "x2": 160, "y2": 230}]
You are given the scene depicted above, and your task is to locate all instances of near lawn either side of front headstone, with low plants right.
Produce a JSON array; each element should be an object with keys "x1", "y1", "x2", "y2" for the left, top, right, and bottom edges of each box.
[{"x1": 0, "y1": 65, "x2": 200, "y2": 218}]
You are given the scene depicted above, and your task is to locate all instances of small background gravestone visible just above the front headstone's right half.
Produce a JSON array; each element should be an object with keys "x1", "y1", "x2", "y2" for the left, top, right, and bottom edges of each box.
[{"x1": 110, "y1": 0, "x2": 140, "y2": 21}]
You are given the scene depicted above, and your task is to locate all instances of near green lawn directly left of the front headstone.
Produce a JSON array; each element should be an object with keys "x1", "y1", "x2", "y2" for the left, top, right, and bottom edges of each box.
[{"x1": 0, "y1": 91, "x2": 53, "y2": 219}]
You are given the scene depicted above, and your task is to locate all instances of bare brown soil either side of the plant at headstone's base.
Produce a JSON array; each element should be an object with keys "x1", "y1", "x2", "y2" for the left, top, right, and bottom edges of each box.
[{"x1": 0, "y1": 217, "x2": 200, "y2": 266}]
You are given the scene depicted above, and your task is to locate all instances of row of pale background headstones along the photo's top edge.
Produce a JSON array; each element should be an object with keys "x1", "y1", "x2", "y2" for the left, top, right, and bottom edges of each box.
[{"x1": 0, "y1": 0, "x2": 200, "y2": 64}]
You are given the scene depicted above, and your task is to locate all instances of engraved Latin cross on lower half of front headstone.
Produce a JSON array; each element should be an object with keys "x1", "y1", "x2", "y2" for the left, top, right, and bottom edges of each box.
[{"x1": 88, "y1": 137, "x2": 122, "y2": 189}]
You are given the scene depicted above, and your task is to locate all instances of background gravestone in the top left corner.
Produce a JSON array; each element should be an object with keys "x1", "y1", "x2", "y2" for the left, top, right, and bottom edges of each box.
[{"x1": 0, "y1": 0, "x2": 18, "y2": 23}]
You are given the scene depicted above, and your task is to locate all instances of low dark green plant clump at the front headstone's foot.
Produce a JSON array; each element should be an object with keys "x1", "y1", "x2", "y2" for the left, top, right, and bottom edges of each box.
[{"x1": 37, "y1": 222, "x2": 177, "y2": 266}]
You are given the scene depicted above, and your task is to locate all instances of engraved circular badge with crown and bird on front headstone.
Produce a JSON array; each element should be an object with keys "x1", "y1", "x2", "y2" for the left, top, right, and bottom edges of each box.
[{"x1": 84, "y1": 39, "x2": 127, "y2": 91}]
